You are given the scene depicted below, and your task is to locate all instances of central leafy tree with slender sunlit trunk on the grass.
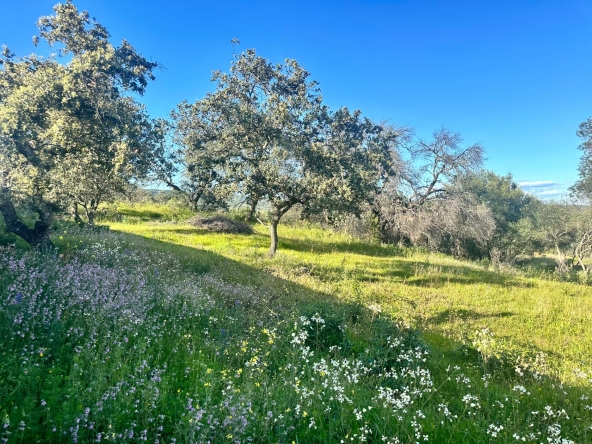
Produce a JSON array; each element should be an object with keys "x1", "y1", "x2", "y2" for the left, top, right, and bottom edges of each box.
[{"x1": 173, "y1": 50, "x2": 395, "y2": 256}]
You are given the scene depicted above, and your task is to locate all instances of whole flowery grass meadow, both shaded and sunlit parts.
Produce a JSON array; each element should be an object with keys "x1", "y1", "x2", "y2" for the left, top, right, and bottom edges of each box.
[{"x1": 0, "y1": 207, "x2": 592, "y2": 443}]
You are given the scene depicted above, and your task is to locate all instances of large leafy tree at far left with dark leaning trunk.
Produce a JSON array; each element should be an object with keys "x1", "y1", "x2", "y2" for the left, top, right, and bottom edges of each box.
[{"x1": 0, "y1": 1, "x2": 157, "y2": 247}]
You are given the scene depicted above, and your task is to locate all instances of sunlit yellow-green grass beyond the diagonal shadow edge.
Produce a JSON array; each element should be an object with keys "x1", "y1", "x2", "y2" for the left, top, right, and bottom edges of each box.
[{"x1": 110, "y1": 217, "x2": 592, "y2": 384}]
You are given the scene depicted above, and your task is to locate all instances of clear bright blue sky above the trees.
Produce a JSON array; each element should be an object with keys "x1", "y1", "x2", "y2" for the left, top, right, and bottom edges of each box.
[{"x1": 0, "y1": 0, "x2": 592, "y2": 196}]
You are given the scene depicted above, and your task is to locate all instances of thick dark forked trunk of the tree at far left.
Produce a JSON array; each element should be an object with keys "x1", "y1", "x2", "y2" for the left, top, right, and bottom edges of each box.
[{"x1": 0, "y1": 198, "x2": 55, "y2": 250}]
